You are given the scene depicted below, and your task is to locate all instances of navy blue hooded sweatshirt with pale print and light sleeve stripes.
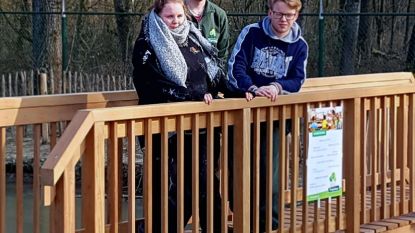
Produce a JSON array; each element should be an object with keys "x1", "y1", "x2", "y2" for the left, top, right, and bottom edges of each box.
[{"x1": 228, "y1": 17, "x2": 308, "y2": 92}]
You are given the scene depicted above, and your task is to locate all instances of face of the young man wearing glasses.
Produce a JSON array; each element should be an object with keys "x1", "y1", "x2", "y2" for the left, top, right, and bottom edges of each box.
[{"x1": 268, "y1": 1, "x2": 298, "y2": 38}]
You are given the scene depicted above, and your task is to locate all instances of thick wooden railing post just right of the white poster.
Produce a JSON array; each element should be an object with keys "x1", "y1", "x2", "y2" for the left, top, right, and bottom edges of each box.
[{"x1": 343, "y1": 98, "x2": 364, "y2": 233}]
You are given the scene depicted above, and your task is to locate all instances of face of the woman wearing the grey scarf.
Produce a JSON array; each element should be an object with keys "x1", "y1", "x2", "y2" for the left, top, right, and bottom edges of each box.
[{"x1": 159, "y1": 2, "x2": 186, "y2": 29}]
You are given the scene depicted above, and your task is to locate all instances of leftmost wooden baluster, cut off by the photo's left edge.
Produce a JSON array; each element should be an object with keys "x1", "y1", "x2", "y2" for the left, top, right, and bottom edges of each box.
[{"x1": 0, "y1": 127, "x2": 6, "y2": 232}]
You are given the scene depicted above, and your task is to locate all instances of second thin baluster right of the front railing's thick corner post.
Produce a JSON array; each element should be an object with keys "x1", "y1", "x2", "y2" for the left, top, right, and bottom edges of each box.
[{"x1": 127, "y1": 120, "x2": 136, "y2": 233}]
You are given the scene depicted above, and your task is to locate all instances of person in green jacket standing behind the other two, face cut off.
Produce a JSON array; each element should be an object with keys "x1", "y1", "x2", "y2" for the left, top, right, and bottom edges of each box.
[{"x1": 186, "y1": 0, "x2": 229, "y2": 64}]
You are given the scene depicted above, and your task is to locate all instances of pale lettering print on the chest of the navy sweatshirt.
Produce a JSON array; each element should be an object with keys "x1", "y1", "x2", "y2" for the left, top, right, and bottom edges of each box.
[{"x1": 251, "y1": 46, "x2": 292, "y2": 79}]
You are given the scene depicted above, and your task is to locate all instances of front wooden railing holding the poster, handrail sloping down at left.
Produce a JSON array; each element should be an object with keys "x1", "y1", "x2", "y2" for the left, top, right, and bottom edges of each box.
[{"x1": 38, "y1": 74, "x2": 415, "y2": 232}]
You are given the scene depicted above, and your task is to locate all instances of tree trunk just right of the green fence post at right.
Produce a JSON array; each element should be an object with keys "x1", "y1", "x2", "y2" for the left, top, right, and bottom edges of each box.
[{"x1": 340, "y1": 0, "x2": 360, "y2": 75}]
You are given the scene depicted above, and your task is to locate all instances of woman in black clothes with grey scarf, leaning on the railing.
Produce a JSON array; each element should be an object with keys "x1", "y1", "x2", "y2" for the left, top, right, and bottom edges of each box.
[{"x1": 133, "y1": 0, "x2": 245, "y2": 232}]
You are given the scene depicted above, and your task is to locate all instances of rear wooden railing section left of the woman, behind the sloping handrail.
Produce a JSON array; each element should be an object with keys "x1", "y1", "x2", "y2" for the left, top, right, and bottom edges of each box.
[{"x1": 0, "y1": 91, "x2": 137, "y2": 233}]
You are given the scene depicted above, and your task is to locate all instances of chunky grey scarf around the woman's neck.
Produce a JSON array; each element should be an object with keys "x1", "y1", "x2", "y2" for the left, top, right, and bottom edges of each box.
[{"x1": 148, "y1": 10, "x2": 218, "y2": 87}]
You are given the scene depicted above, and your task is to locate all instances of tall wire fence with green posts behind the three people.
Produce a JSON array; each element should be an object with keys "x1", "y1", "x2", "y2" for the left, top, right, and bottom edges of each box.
[{"x1": 0, "y1": 12, "x2": 415, "y2": 96}]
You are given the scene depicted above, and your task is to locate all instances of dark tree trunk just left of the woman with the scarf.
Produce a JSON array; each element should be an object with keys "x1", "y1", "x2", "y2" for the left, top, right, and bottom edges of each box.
[{"x1": 114, "y1": 0, "x2": 132, "y2": 74}]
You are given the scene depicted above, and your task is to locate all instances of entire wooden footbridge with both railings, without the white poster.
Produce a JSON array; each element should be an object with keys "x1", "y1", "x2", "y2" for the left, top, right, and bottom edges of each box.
[{"x1": 0, "y1": 73, "x2": 415, "y2": 233}]
